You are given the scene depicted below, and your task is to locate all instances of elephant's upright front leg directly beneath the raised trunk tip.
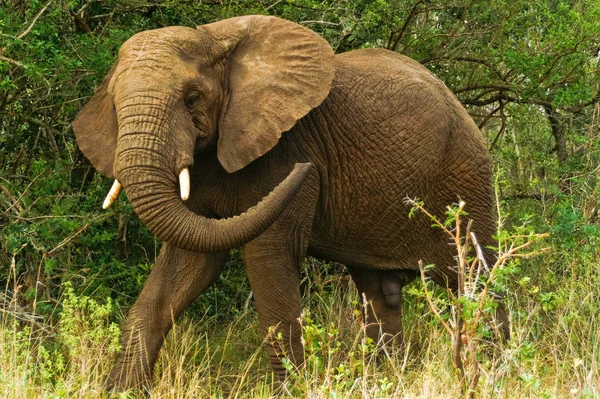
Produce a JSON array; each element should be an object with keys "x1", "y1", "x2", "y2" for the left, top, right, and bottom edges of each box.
[{"x1": 243, "y1": 183, "x2": 318, "y2": 380}]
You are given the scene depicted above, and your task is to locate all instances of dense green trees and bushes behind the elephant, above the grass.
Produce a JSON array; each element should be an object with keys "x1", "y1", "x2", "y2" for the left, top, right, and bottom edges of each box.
[{"x1": 0, "y1": 0, "x2": 600, "y2": 398}]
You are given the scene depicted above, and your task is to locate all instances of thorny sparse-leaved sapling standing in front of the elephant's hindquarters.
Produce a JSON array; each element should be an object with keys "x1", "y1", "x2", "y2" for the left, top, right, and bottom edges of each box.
[{"x1": 407, "y1": 199, "x2": 548, "y2": 398}]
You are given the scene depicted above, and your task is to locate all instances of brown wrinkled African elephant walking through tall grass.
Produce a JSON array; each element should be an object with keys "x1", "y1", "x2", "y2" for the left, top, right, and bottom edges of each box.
[{"x1": 73, "y1": 16, "x2": 508, "y2": 390}]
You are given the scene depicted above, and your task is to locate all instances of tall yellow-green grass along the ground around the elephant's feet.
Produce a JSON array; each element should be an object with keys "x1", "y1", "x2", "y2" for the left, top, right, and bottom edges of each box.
[{"x1": 0, "y1": 256, "x2": 600, "y2": 398}]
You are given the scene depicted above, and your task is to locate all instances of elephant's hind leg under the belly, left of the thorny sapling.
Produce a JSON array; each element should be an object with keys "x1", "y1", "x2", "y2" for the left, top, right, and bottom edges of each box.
[{"x1": 348, "y1": 267, "x2": 417, "y2": 347}]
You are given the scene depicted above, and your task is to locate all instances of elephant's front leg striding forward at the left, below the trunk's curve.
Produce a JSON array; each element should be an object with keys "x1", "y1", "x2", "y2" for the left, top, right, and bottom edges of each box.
[{"x1": 105, "y1": 244, "x2": 227, "y2": 391}]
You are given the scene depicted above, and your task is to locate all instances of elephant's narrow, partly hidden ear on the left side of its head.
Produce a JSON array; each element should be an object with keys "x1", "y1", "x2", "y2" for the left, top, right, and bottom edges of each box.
[{"x1": 73, "y1": 63, "x2": 118, "y2": 179}]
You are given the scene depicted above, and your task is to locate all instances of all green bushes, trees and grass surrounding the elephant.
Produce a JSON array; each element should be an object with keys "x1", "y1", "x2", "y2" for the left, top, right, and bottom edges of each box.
[{"x1": 0, "y1": 0, "x2": 600, "y2": 398}]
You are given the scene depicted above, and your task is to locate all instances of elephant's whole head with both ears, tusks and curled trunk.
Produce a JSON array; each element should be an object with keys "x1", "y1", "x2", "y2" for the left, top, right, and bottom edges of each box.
[{"x1": 73, "y1": 16, "x2": 334, "y2": 252}]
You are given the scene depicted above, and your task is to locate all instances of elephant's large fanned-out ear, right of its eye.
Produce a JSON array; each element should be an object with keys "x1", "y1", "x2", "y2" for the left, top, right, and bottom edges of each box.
[{"x1": 198, "y1": 15, "x2": 335, "y2": 173}]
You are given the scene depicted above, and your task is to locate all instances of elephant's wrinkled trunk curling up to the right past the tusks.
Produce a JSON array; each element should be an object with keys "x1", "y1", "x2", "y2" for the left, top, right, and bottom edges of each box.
[{"x1": 116, "y1": 131, "x2": 311, "y2": 252}]
